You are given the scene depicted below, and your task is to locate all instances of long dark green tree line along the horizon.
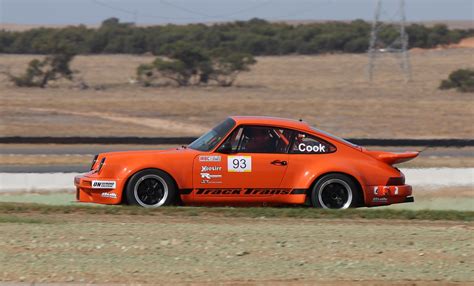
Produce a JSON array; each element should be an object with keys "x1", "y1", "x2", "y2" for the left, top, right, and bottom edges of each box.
[{"x1": 0, "y1": 18, "x2": 474, "y2": 56}]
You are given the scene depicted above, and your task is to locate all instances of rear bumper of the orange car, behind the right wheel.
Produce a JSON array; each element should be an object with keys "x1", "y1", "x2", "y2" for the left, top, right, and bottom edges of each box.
[{"x1": 366, "y1": 185, "x2": 415, "y2": 206}]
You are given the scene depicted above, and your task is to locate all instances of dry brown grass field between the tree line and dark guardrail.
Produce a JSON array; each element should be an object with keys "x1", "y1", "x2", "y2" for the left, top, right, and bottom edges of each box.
[{"x1": 0, "y1": 49, "x2": 474, "y2": 138}]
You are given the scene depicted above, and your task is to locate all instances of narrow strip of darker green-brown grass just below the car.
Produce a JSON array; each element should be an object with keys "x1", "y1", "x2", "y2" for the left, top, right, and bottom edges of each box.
[{"x1": 0, "y1": 203, "x2": 474, "y2": 223}]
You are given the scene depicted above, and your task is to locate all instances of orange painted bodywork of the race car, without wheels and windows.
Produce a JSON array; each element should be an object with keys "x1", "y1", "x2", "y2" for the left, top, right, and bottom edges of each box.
[{"x1": 74, "y1": 116, "x2": 418, "y2": 206}]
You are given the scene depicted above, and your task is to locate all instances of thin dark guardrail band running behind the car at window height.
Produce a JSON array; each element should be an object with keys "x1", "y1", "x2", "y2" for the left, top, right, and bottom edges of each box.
[{"x1": 0, "y1": 136, "x2": 474, "y2": 147}]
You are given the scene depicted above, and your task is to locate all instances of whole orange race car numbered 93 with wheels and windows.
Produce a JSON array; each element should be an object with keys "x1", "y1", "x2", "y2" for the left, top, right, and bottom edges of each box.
[{"x1": 74, "y1": 116, "x2": 418, "y2": 209}]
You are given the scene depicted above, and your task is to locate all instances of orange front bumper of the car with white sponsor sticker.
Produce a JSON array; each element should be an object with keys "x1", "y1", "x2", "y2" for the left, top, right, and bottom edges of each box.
[{"x1": 74, "y1": 172, "x2": 123, "y2": 205}]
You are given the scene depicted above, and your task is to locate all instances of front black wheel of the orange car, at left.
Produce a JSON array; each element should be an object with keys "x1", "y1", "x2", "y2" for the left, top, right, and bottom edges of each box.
[{"x1": 126, "y1": 169, "x2": 177, "y2": 208}]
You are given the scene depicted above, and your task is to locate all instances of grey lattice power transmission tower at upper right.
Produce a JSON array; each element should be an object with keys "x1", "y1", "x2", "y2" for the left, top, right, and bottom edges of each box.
[{"x1": 367, "y1": 0, "x2": 411, "y2": 82}]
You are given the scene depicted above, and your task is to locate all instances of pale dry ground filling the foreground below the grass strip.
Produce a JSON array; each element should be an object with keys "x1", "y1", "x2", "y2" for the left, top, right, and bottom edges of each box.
[{"x1": 0, "y1": 214, "x2": 474, "y2": 285}]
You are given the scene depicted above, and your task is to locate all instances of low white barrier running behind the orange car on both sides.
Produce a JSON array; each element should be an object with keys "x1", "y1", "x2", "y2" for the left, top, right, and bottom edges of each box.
[{"x1": 0, "y1": 168, "x2": 474, "y2": 192}]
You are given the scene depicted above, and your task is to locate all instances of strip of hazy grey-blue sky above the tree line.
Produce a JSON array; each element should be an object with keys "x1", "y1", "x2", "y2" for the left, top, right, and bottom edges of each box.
[{"x1": 0, "y1": 0, "x2": 474, "y2": 25}]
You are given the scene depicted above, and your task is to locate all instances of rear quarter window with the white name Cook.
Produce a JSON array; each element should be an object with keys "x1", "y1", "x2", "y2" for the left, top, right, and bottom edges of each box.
[{"x1": 290, "y1": 132, "x2": 336, "y2": 154}]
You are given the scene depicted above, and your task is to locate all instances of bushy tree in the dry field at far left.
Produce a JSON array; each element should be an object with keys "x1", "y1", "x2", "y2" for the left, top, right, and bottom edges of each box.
[{"x1": 7, "y1": 50, "x2": 74, "y2": 88}]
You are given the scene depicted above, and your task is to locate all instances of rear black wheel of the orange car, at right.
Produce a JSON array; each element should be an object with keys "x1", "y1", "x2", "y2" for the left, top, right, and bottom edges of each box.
[{"x1": 311, "y1": 174, "x2": 359, "y2": 209}]
